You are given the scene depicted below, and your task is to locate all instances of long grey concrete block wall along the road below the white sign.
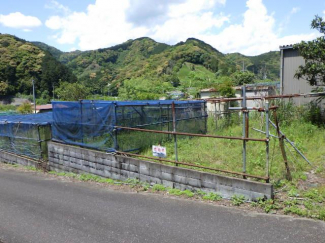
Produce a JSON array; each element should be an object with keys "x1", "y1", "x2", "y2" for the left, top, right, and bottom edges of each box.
[{"x1": 48, "y1": 142, "x2": 273, "y2": 200}]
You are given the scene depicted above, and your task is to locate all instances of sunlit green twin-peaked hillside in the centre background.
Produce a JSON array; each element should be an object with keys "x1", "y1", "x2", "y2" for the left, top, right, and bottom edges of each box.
[{"x1": 42, "y1": 37, "x2": 236, "y2": 99}]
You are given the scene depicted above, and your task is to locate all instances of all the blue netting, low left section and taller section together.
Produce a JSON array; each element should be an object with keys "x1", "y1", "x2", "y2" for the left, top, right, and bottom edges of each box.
[{"x1": 0, "y1": 100, "x2": 207, "y2": 159}]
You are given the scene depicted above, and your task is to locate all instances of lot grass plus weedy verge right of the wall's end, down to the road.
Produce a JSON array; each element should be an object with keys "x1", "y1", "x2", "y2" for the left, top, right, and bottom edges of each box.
[{"x1": 137, "y1": 104, "x2": 325, "y2": 220}]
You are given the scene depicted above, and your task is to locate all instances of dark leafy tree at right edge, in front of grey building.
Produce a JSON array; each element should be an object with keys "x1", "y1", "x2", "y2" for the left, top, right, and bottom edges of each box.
[{"x1": 294, "y1": 15, "x2": 325, "y2": 86}]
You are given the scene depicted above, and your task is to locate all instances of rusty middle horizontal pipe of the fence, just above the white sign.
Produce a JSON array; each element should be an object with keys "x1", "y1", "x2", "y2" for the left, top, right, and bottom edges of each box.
[{"x1": 114, "y1": 126, "x2": 268, "y2": 142}]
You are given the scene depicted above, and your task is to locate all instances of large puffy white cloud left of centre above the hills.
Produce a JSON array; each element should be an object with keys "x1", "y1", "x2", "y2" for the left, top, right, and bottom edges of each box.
[{"x1": 45, "y1": 0, "x2": 147, "y2": 50}]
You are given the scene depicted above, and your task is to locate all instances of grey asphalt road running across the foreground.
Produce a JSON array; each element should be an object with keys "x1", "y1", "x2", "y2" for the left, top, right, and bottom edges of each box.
[{"x1": 0, "y1": 168, "x2": 325, "y2": 243}]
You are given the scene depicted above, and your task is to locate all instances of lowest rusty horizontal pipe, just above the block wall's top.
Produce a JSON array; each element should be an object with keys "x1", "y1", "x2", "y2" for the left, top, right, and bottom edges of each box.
[{"x1": 116, "y1": 151, "x2": 269, "y2": 182}]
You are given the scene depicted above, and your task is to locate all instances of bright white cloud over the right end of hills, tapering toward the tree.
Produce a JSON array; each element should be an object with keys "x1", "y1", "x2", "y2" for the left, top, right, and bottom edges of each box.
[{"x1": 200, "y1": 0, "x2": 317, "y2": 55}]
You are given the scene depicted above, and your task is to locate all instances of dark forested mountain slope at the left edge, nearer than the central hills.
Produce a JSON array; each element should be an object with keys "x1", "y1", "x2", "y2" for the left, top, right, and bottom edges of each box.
[{"x1": 0, "y1": 34, "x2": 77, "y2": 97}]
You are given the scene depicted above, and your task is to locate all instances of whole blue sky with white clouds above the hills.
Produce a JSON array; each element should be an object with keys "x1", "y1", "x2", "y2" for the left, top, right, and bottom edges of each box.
[{"x1": 0, "y1": 0, "x2": 325, "y2": 55}]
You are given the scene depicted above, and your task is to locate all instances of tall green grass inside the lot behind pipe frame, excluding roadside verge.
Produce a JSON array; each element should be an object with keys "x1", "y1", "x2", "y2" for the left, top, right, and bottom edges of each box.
[{"x1": 143, "y1": 103, "x2": 325, "y2": 179}]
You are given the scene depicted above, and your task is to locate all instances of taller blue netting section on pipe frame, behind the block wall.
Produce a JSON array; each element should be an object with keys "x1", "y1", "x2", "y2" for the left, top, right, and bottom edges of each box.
[{"x1": 52, "y1": 100, "x2": 207, "y2": 151}]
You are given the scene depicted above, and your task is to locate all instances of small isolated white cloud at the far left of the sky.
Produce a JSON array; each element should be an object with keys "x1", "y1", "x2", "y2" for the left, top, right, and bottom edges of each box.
[{"x1": 0, "y1": 12, "x2": 42, "y2": 31}]
